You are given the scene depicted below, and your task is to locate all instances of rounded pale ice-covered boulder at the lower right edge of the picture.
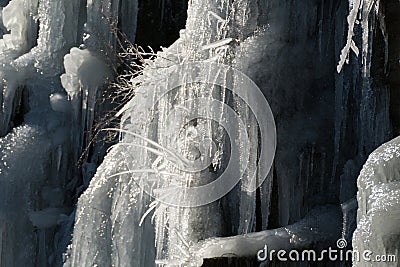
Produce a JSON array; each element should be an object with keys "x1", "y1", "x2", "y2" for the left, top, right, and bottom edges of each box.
[{"x1": 353, "y1": 137, "x2": 400, "y2": 266}]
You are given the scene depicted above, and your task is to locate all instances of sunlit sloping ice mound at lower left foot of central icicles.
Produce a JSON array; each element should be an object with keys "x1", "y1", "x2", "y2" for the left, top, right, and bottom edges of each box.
[{"x1": 64, "y1": 147, "x2": 155, "y2": 266}]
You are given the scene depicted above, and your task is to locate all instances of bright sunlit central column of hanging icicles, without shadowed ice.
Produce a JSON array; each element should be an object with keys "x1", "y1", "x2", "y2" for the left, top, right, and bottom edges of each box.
[{"x1": 66, "y1": 0, "x2": 276, "y2": 266}]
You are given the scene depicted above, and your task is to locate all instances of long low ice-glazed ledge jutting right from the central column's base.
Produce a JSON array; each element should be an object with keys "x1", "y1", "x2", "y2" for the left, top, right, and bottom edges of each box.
[{"x1": 188, "y1": 205, "x2": 342, "y2": 266}]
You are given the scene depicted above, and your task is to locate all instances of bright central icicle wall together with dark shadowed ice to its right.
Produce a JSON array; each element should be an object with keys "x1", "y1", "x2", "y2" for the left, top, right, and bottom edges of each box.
[{"x1": 68, "y1": 0, "x2": 390, "y2": 266}]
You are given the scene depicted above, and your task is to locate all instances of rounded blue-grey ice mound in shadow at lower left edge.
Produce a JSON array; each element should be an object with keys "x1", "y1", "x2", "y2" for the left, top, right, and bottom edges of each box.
[{"x1": 0, "y1": 126, "x2": 62, "y2": 266}]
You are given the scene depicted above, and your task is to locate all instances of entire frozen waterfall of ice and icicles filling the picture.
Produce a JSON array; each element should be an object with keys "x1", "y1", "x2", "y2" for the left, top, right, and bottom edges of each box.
[{"x1": 0, "y1": 0, "x2": 400, "y2": 266}]
